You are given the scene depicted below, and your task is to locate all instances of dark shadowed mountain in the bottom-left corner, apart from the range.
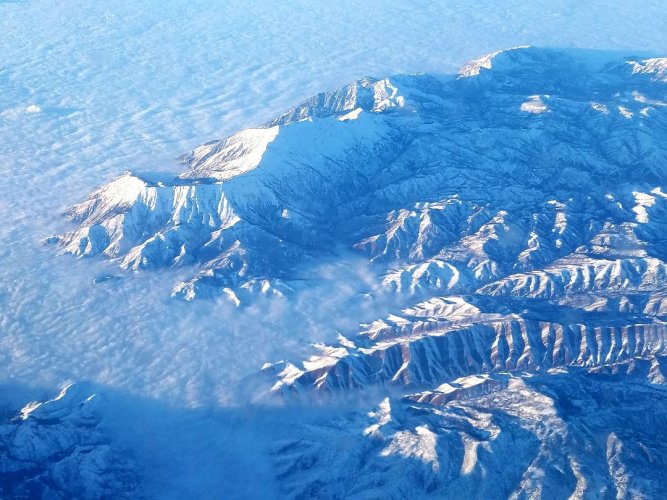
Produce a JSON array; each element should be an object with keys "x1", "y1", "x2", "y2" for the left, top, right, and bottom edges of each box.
[{"x1": 0, "y1": 385, "x2": 143, "y2": 499}]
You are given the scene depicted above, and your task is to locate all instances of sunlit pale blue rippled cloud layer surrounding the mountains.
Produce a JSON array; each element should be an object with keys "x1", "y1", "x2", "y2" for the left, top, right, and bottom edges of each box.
[{"x1": 0, "y1": 0, "x2": 667, "y2": 498}]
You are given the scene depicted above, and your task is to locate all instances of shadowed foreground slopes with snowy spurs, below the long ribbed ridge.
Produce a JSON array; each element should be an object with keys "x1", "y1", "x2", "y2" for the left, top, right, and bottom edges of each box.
[{"x1": 273, "y1": 370, "x2": 667, "y2": 499}]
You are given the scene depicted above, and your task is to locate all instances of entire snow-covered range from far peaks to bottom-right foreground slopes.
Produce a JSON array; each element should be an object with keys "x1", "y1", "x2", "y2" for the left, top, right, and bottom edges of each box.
[{"x1": 43, "y1": 48, "x2": 667, "y2": 498}]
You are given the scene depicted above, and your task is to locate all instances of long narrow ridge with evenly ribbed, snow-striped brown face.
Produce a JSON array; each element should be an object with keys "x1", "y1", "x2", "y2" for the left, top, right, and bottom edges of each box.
[{"x1": 265, "y1": 318, "x2": 667, "y2": 394}]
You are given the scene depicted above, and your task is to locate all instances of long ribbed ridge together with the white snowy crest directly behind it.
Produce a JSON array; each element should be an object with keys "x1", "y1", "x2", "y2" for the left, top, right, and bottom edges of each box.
[{"x1": 264, "y1": 296, "x2": 667, "y2": 393}]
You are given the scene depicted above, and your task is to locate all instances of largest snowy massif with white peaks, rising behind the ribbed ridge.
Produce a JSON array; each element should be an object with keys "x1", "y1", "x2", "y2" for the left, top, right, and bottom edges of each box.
[{"x1": 54, "y1": 48, "x2": 667, "y2": 302}]
